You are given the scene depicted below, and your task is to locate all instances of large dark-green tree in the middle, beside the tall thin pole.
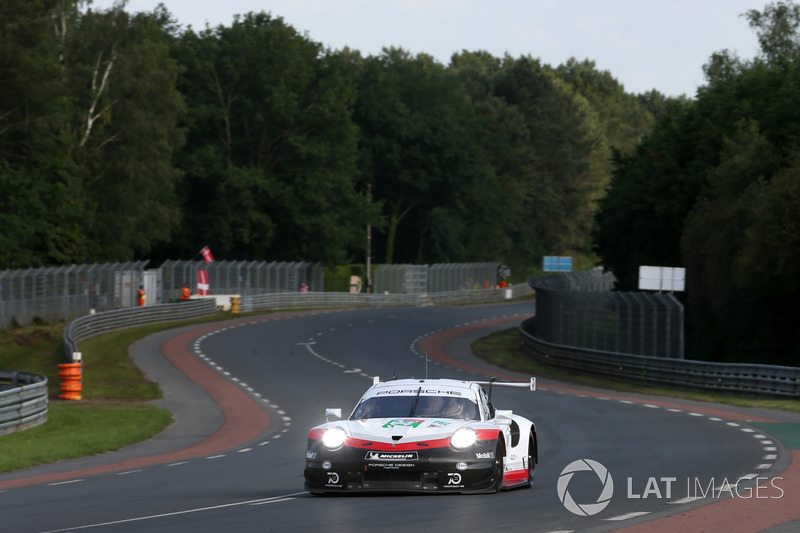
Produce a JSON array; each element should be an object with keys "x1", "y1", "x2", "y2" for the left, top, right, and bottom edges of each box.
[{"x1": 354, "y1": 48, "x2": 500, "y2": 263}]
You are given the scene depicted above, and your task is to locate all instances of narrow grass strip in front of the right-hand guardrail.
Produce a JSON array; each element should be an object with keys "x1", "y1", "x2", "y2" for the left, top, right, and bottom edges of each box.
[{"x1": 472, "y1": 328, "x2": 800, "y2": 413}]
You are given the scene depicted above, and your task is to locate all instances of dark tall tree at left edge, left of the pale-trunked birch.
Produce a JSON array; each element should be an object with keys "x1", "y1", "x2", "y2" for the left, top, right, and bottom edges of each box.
[{"x1": 0, "y1": 0, "x2": 87, "y2": 268}]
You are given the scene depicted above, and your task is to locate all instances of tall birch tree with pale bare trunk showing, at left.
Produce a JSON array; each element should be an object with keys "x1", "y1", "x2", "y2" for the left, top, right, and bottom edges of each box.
[{"x1": 64, "y1": 6, "x2": 185, "y2": 260}]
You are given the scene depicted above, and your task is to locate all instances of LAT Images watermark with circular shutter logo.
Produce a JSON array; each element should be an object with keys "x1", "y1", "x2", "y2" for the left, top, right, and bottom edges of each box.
[{"x1": 557, "y1": 459, "x2": 785, "y2": 516}]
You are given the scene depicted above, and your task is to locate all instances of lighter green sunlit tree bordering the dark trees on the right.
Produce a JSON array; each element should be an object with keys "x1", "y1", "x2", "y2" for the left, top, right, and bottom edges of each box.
[{"x1": 496, "y1": 57, "x2": 608, "y2": 255}]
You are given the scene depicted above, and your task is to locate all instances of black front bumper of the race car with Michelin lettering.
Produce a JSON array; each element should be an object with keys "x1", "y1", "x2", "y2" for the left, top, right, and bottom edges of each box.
[{"x1": 305, "y1": 441, "x2": 497, "y2": 493}]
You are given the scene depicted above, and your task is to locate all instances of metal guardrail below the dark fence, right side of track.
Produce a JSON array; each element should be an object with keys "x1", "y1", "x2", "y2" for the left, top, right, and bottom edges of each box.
[{"x1": 519, "y1": 317, "x2": 800, "y2": 398}]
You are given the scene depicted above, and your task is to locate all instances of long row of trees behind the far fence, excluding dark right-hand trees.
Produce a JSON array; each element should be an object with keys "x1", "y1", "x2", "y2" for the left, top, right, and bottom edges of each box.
[{"x1": 0, "y1": 0, "x2": 665, "y2": 268}]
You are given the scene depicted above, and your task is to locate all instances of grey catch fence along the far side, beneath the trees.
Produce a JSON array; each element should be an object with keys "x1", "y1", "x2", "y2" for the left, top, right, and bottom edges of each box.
[{"x1": 0, "y1": 260, "x2": 520, "y2": 329}]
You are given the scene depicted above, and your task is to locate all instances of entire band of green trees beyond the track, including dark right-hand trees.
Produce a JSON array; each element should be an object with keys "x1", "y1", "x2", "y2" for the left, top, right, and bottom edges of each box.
[{"x1": 0, "y1": 0, "x2": 800, "y2": 364}]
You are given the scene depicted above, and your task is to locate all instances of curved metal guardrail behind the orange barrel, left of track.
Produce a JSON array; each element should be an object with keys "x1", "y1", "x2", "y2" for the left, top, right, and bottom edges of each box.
[{"x1": 64, "y1": 298, "x2": 218, "y2": 362}]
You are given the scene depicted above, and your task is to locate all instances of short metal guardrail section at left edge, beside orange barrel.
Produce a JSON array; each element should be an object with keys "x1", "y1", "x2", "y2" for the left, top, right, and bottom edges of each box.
[{"x1": 0, "y1": 370, "x2": 48, "y2": 435}]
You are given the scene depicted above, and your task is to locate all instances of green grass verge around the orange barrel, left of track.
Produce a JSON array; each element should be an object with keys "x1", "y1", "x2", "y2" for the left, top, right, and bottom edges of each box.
[{"x1": 0, "y1": 314, "x2": 262, "y2": 472}]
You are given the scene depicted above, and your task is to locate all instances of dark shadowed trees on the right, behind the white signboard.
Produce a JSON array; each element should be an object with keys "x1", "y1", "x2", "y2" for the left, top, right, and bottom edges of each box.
[{"x1": 594, "y1": 2, "x2": 800, "y2": 366}]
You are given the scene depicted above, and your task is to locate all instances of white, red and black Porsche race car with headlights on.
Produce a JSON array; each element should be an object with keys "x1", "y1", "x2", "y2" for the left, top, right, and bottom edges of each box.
[{"x1": 305, "y1": 377, "x2": 538, "y2": 494}]
